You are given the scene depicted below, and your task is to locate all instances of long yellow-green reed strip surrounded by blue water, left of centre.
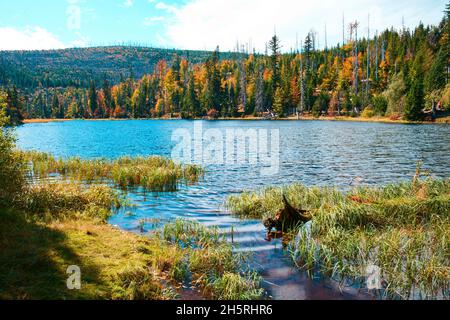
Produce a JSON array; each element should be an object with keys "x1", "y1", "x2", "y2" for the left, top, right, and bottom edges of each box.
[{"x1": 20, "y1": 151, "x2": 204, "y2": 192}]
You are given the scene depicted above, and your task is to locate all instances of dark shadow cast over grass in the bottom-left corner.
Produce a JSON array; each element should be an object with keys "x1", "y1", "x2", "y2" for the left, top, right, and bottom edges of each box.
[{"x1": 0, "y1": 208, "x2": 102, "y2": 300}]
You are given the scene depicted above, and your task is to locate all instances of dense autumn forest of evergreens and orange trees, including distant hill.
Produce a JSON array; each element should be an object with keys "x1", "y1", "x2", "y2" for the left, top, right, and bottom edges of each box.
[{"x1": 0, "y1": 4, "x2": 450, "y2": 121}]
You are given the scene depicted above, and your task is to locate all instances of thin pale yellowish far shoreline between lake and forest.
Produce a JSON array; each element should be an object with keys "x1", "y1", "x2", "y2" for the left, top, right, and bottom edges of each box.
[{"x1": 23, "y1": 116, "x2": 450, "y2": 124}]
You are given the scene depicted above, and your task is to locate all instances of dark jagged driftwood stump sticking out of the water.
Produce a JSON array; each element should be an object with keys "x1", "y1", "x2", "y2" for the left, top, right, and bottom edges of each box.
[{"x1": 264, "y1": 195, "x2": 311, "y2": 234}]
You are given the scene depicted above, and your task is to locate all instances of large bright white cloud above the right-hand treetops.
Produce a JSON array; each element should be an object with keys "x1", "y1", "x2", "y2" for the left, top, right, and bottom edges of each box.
[{"x1": 158, "y1": 0, "x2": 446, "y2": 51}]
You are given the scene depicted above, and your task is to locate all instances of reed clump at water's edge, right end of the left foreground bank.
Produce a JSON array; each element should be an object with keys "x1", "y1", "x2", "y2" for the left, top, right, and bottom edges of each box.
[{"x1": 158, "y1": 220, "x2": 263, "y2": 300}]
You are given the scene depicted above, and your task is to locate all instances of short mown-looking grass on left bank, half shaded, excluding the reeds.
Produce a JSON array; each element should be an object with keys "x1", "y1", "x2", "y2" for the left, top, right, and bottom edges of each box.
[{"x1": 0, "y1": 210, "x2": 165, "y2": 300}]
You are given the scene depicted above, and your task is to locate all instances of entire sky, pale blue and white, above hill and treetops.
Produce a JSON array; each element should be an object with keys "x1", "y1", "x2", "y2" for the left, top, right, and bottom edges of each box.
[{"x1": 0, "y1": 0, "x2": 448, "y2": 52}]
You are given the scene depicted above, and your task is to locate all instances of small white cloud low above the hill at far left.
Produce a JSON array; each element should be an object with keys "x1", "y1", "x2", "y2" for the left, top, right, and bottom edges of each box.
[{"x1": 0, "y1": 26, "x2": 66, "y2": 50}]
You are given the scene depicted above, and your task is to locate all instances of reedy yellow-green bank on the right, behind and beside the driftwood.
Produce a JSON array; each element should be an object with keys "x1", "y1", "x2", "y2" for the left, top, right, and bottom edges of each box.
[{"x1": 227, "y1": 177, "x2": 450, "y2": 299}]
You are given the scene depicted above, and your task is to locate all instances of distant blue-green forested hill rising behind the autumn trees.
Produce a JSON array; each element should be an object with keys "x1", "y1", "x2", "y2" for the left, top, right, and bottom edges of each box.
[{"x1": 0, "y1": 46, "x2": 239, "y2": 89}]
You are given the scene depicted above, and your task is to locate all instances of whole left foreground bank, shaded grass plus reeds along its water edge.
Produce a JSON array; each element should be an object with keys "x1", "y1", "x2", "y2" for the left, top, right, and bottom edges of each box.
[{"x1": 0, "y1": 182, "x2": 263, "y2": 300}]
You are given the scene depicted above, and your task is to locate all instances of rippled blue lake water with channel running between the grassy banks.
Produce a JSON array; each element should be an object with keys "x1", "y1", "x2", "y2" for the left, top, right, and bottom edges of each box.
[{"x1": 17, "y1": 120, "x2": 450, "y2": 299}]
